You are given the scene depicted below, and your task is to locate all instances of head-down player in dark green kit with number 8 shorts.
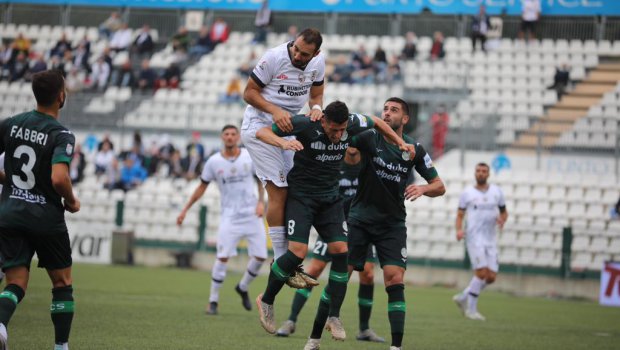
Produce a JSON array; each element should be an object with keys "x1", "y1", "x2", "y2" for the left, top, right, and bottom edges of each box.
[{"x1": 256, "y1": 101, "x2": 413, "y2": 348}]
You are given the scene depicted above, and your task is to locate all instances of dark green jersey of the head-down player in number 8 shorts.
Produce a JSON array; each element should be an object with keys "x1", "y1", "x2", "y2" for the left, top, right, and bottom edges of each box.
[{"x1": 272, "y1": 114, "x2": 374, "y2": 197}]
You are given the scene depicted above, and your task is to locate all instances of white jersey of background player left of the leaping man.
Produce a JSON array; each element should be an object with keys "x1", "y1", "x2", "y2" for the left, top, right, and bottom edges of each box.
[{"x1": 200, "y1": 148, "x2": 258, "y2": 221}]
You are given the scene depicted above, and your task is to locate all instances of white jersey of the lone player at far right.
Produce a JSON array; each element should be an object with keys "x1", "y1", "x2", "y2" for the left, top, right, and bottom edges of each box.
[{"x1": 459, "y1": 184, "x2": 506, "y2": 244}]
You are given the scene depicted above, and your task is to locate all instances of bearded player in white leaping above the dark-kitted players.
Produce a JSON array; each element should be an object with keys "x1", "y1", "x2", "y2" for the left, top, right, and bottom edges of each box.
[{"x1": 241, "y1": 28, "x2": 325, "y2": 288}]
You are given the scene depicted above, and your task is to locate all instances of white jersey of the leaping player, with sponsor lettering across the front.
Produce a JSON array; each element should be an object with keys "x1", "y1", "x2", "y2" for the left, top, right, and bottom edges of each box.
[{"x1": 242, "y1": 41, "x2": 325, "y2": 129}]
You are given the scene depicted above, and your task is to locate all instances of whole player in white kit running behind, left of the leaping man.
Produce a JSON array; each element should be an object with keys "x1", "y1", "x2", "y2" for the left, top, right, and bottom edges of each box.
[{"x1": 177, "y1": 125, "x2": 267, "y2": 315}]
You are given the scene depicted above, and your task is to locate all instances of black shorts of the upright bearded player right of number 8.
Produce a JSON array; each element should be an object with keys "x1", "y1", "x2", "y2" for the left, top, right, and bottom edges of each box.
[{"x1": 349, "y1": 224, "x2": 407, "y2": 271}]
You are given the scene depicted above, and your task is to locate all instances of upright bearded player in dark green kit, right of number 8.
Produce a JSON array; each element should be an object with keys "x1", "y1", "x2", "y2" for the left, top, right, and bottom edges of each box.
[{"x1": 349, "y1": 97, "x2": 446, "y2": 350}]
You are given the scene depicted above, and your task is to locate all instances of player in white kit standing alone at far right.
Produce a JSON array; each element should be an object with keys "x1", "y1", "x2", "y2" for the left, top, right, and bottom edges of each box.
[{"x1": 453, "y1": 163, "x2": 508, "y2": 321}]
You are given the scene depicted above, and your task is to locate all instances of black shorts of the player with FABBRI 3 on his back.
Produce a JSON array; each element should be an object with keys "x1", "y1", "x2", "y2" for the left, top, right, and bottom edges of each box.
[{"x1": 0, "y1": 229, "x2": 73, "y2": 271}]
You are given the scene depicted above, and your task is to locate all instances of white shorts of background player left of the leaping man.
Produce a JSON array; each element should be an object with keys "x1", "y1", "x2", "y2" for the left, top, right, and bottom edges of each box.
[{"x1": 217, "y1": 217, "x2": 267, "y2": 259}]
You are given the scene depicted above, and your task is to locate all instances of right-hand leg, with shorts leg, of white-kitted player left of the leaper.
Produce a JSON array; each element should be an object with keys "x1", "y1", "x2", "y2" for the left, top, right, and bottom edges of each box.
[{"x1": 235, "y1": 219, "x2": 267, "y2": 311}]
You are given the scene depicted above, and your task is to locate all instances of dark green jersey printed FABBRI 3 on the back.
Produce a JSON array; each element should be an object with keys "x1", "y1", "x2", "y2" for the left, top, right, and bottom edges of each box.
[{"x1": 0, "y1": 111, "x2": 75, "y2": 233}]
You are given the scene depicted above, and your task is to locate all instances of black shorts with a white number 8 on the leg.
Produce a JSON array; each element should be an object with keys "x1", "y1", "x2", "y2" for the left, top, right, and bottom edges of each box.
[{"x1": 285, "y1": 194, "x2": 347, "y2": 244}]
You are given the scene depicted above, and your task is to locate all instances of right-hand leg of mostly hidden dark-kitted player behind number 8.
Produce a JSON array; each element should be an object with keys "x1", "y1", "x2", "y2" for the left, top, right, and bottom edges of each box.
[{"x1": 356, "y1": 245, "x2": 385, "y2": 343}]
